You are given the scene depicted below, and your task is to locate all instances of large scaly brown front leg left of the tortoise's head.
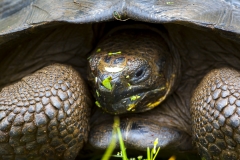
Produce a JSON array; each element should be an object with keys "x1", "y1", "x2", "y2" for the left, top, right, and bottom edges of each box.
[{"x1": 0, "y1": 64, "x2": 91, "y2": 159}]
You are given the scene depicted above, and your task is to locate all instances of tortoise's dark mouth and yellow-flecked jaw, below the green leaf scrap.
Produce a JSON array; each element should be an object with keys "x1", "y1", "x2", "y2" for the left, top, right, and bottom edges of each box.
[{"x1": 93, "y1": 74, "x2": 168, "y2": 115}]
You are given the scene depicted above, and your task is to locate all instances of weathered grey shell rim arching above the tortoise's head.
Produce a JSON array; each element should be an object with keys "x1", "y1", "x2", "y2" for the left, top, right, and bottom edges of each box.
[{"x1": 0, "y1": 0, "x2": 240, "y2": 44}]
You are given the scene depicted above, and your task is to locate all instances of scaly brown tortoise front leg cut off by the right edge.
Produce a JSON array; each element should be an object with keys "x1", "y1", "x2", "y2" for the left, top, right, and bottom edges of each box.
[{"x1": 191, "y1": 68, "x2": 240, "y2": 160}]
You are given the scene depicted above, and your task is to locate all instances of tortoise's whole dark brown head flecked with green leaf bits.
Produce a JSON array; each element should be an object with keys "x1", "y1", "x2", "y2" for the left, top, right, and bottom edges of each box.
[{"x1": 88, "y1": 29, "x2": 179, "y2": 114}]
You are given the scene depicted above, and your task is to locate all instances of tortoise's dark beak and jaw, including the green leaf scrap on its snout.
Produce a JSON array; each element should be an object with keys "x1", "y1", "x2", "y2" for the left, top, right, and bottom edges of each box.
[{"x1": 93, "y1": 70, "x2": 169, "y2": 114}]
